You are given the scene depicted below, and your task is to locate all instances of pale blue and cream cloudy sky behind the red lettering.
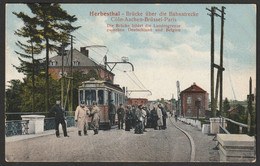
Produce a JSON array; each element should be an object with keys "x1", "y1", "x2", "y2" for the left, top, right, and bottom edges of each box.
[{"x1": 6, "y1": 4, "x2": 256, "y2": 100}]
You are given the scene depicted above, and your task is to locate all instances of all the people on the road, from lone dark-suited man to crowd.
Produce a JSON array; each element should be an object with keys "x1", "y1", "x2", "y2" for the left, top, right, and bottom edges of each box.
[{"x1": 50, "y1": 100, "x2": 168, "y2": 137}]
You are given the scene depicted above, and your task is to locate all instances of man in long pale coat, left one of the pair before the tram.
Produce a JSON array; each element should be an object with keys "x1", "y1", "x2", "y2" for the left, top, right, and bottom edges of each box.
[{"x1": 75, "y1": 101, "x2": 90, "y2": 136}]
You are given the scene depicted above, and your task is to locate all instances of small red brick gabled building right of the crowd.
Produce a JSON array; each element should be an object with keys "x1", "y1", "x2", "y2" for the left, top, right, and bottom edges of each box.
[{"x1": 180, "y1": 83, "x2": 209, "y2": 117}]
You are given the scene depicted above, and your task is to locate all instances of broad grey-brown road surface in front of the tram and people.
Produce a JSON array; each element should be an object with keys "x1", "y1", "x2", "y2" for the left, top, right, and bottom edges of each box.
[{"x1": 6, "y1": 116, "x2": 191, "y2": 162}]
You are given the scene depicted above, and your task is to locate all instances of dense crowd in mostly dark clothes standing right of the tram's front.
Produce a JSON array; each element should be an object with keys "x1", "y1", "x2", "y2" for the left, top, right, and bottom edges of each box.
[{"x1": 108, "y1": 100, "x2": 168, "y2": 134}]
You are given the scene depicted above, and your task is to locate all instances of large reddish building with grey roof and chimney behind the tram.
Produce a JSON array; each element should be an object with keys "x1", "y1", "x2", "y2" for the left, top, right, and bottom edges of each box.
[{"x1": 49, "y1": 47, "x2": 115, "y2": 83}]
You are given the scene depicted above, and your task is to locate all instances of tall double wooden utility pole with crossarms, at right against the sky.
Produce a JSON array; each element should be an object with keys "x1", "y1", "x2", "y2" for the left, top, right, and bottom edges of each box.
[{"x1": 206, "y1": 6, "x2": 225, "y2": 117}]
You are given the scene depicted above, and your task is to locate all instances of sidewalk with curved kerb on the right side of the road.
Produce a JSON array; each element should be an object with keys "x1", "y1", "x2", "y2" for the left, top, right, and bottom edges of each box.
[{"x1": 172, "y1": 119, "x2": 220, "y2": 162}]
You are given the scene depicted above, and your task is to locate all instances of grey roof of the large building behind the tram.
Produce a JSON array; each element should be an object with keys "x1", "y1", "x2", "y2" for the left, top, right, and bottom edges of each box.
[{"x1": 50, "y1": 48, "x2": 114, "y2": 75}]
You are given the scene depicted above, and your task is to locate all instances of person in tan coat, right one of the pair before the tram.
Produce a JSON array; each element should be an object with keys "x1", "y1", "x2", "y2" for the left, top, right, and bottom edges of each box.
[{"x1": 90, "y1": 101, "x2": 100, "y2": 135}]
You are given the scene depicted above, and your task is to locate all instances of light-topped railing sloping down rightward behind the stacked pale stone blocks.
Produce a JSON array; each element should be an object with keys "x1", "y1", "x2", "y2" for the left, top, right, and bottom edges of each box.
[{"x1": 220, "y1": 117, "x2": 248, "y2": 134}]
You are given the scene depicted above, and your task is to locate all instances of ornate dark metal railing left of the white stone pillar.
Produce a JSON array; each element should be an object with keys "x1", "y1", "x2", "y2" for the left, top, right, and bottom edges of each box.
[{"x1": 5, "y1": 120, "x2": 29, "y2": 137}]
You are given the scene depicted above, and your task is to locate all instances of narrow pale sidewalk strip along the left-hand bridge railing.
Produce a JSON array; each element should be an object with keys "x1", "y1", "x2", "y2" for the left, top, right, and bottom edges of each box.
[{"x1": 5, "y1": 127, "x2": 77, "y2": 143}]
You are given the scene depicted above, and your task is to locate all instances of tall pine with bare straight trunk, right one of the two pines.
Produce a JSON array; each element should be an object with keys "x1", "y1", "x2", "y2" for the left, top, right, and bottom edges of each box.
[{"x1": 27, "y1": 3, "x2": 79, "y2": 111}]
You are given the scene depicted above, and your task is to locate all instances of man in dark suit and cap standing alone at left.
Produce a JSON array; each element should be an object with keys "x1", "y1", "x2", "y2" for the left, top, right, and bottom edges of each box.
[{"x1": 50, "y1": 99, "x2": 69, "y2": 138}]
